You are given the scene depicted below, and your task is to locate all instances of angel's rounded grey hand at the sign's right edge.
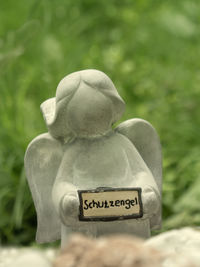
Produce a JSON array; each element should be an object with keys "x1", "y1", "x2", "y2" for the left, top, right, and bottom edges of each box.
[{"x1": 142, "y1": 187, "x2": 160, "y2": 219}]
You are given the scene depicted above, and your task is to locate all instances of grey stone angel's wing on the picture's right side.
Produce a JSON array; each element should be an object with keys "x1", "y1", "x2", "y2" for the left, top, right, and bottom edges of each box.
[{"x1": 116, "y1": 119, "x2": 162, "y2": 229}]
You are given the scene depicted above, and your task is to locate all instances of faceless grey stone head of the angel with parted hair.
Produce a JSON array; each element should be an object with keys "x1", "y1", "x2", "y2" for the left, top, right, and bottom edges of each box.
[{"x1": 41, "y1": 70, "x2": 125, "y2": 138}]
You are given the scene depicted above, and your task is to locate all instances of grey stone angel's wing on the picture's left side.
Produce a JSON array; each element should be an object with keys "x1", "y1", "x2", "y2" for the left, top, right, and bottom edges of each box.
[{"x1": 24, "y1": 133, "x2": 62, "y2": 243}]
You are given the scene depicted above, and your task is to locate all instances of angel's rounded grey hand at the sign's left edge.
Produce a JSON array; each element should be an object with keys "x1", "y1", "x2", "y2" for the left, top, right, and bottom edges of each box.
[{"x1": 60, "y1": 194, "x2": 79, "y2": 226}]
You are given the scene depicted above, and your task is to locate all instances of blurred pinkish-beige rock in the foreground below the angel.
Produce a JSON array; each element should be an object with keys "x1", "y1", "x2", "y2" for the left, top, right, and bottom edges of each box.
[{"x1": 54, "y1": 235, "x2": 162, "y2": 267}]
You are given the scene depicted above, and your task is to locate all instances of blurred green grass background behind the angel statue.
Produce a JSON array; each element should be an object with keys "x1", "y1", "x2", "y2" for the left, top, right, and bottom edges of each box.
[{"x1": 0, "y1": 0, "x2": 200, "y2": 245}]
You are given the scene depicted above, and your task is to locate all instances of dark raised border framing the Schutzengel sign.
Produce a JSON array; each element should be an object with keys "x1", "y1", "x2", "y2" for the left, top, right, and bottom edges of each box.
[{"x1": 77, "y1": 187, "x2": 143, "y2": 222}]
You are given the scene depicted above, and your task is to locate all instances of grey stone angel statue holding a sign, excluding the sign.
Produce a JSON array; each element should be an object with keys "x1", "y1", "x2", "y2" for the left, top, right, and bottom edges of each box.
[{"x1": 25, "y1": 69, "x2": 162, "y2": 249}]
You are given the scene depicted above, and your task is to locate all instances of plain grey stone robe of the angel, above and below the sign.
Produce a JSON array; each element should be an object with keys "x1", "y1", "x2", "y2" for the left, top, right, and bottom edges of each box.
[{"x1": 53, "y1": 130, "x2": 160, "y2": 248}]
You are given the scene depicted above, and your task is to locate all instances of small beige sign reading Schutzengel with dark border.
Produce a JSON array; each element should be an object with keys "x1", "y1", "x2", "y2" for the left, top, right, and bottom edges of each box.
[{"x1": 78, "y1": 187, "x2": 143, "y2": 221}]
